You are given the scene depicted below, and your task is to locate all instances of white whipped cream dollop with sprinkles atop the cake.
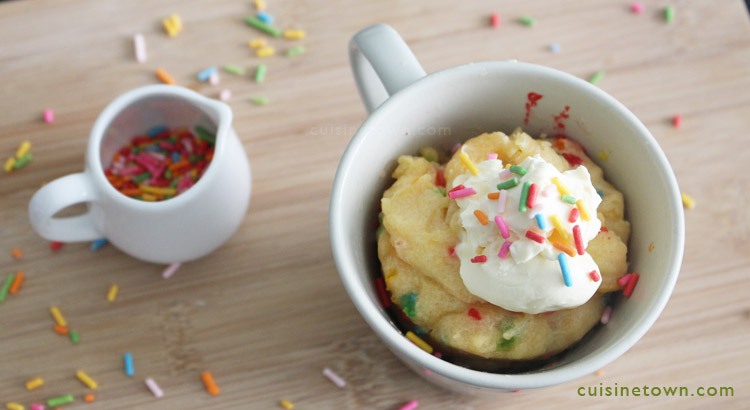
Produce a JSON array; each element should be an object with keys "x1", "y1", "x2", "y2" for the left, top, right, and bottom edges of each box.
[{"x1": 452, "y1": 155, "x2": 601, "y2": 314}]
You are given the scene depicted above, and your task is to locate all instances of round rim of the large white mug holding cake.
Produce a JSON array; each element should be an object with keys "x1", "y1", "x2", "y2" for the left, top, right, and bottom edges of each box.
[{"x1": 329, "y1": 60, "x2": 685, "y2": 390}]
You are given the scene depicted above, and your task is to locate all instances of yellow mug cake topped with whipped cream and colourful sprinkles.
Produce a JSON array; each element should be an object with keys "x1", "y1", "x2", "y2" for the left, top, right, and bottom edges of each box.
[{"x1": 377, "y1": 128, "x2": 637, "y2": 370}]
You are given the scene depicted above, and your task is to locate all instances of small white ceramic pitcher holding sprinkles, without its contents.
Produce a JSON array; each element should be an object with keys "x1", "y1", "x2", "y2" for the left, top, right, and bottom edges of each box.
[{"x1": 29, "y1": 85, "x2": 250, "y2": 263}]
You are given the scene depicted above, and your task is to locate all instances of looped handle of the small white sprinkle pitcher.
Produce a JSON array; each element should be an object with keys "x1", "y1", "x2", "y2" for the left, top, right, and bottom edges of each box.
[{"x1": 29, "y1": 172, "x2": 104, "y2": 242}]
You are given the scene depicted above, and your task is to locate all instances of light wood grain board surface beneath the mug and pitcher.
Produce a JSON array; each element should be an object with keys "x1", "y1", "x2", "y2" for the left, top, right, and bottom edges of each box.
[{"x1": 0, "y1": 0, "x2": 750, "y2": 409}]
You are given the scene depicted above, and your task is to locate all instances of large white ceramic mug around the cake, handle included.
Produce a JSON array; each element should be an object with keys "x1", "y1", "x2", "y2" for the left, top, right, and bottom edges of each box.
[{"x1": 329, "y1": 24, "x2": 684, "y2": 394}]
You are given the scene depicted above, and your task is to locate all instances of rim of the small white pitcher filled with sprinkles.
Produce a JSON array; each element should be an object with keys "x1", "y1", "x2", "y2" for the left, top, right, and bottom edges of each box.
[{"x1": 85, "y1": 84, "x2": 232, "y2": 211}]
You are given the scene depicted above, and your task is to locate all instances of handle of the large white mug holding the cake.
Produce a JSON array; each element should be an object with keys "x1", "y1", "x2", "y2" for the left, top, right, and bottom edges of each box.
[{"x1": 349, "y1": 24, "x2": 426, "y2": 112}]
